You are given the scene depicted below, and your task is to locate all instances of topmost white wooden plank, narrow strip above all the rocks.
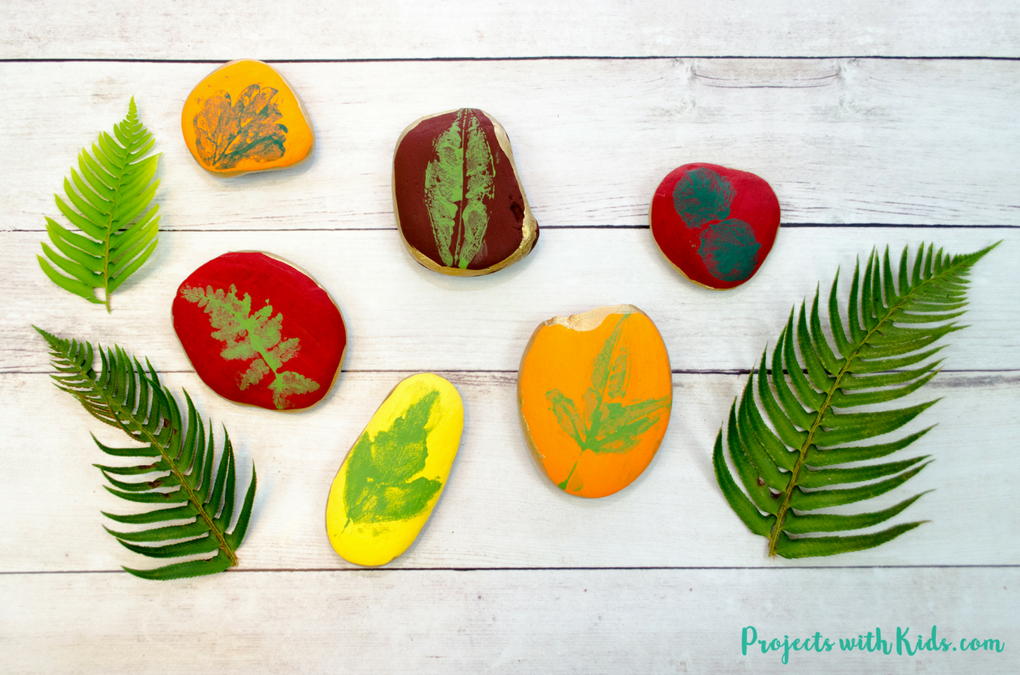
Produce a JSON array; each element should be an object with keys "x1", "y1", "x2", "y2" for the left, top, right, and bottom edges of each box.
[{"x1": 0, "y1": 0, "x2": 1020, "y2": 60}]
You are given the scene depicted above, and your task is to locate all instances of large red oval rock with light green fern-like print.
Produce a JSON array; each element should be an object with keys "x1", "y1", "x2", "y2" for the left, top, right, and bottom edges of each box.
[{"x1": 172, "y1": 251, "x2": 347, "y2": 411}]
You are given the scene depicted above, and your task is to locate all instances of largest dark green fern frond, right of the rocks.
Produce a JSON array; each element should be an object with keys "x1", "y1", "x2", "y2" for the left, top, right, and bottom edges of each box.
[{"x1": 713, "y1": 244, "x2": 998, "y2": 558}]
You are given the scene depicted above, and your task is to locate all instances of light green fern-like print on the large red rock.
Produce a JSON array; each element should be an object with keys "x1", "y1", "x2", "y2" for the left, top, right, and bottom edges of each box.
[{"x1": 181, "y1": 284, "x2": 319, "y2": 410}]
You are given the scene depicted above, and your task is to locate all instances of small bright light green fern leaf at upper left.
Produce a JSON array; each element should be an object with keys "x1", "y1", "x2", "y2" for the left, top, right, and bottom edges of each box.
[{"x1": 36, "y1": 98, "x2": 159, "y2": 312}]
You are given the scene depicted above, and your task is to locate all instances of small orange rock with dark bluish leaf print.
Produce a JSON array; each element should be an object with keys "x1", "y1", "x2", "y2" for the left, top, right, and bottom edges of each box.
[{"x1": 181, "y1": 59, "x2": 315, "y2": 175}]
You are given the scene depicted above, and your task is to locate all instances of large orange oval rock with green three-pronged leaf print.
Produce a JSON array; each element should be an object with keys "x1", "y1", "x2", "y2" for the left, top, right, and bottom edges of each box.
[{"x1": 517, "y1": 305, "x2": 673, "y2": 497}]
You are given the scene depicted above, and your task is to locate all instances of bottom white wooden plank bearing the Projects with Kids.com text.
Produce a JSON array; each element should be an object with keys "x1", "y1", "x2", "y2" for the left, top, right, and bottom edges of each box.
[{"x1": 0, "y1": 568, "x2": 1020, "y2": 675}]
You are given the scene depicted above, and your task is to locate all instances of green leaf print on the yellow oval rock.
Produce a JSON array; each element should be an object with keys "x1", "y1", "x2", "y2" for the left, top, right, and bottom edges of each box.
[{"x1": 344, "y1": 390, "x2": 443, "y2": 524}]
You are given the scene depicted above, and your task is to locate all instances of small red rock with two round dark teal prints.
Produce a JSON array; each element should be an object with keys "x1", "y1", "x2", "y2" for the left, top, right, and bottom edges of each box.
[{"x1": 650, "y1": 164, "x2": 779, "y2": 289}]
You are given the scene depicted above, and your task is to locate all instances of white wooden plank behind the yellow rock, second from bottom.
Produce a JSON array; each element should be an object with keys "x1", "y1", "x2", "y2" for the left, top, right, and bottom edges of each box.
[{"x1": 0, "y1": 365, "x2": 1020, "y2": 572}]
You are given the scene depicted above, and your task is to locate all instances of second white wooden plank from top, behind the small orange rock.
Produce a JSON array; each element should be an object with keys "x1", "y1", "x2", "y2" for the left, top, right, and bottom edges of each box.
[{"x1": 0, "y1": 58, "x2": 1020, "y2": 229}]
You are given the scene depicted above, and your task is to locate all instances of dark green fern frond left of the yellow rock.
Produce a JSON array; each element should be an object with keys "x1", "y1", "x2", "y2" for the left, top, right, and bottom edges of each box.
[{"x1": 36, "y1": 328, "x2": 255, "y2": 579}]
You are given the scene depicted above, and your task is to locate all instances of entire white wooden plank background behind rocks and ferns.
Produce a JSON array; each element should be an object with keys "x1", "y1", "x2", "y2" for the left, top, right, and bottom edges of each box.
[{"x1": 0, "y1": 0, "x2": 1020, "y2": 673}]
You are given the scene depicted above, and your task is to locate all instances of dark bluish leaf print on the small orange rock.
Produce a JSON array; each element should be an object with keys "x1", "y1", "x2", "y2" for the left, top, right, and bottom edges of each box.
[{"x1": 194, "y1": 85, "x2": 287, "y2": 169}]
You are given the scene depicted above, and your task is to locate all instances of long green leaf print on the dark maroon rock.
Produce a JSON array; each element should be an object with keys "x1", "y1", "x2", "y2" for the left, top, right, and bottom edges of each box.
[{"x1": 425, "y1": 108, "x2": 496, "y2": 269}]
